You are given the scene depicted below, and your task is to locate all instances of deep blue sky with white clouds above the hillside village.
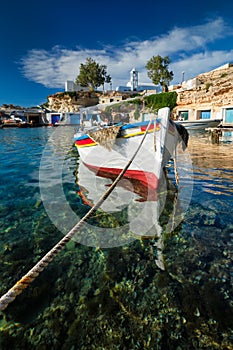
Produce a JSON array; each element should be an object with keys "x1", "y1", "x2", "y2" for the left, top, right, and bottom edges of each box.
[{"x1": 0, "y1": 0, "x2": 233, "y2": 107}]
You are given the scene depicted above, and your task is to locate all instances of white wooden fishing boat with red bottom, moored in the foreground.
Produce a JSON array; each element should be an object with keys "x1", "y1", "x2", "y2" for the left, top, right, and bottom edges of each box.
[{"x1": 74, "y1": 107, "x2": 188, "y2": 190}]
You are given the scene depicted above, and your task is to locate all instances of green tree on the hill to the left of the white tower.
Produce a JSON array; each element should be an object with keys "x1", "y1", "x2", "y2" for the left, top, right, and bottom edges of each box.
[{"x1": 76, "y1": 57, "x2": 111, "y2": 91}]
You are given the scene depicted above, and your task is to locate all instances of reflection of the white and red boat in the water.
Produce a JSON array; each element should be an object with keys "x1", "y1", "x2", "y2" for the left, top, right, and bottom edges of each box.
[{"x1": 74, "y1": 160, "x2": 180, "y2": 269}]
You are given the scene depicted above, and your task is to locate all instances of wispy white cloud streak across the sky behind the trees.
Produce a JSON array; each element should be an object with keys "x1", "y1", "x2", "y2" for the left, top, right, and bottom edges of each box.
[{"x1": 21, "y1": 18, "x2": 233, "y2": 88}]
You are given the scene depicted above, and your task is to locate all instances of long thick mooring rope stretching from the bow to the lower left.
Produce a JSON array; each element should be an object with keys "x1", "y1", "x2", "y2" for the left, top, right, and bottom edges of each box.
[{"x1": 0, "y1": 120, "x2": 152, "y2": 311}]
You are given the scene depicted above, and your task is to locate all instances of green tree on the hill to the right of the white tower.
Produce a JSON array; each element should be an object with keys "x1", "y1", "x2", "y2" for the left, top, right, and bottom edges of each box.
[{"x1": 145, "y1": 55, "x2": 174, "y2": 92}]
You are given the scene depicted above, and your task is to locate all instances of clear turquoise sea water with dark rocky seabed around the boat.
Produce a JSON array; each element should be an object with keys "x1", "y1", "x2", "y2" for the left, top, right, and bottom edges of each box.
[{"x1": 0, "y1": 127, "x2": 233, "y2": 350}]
